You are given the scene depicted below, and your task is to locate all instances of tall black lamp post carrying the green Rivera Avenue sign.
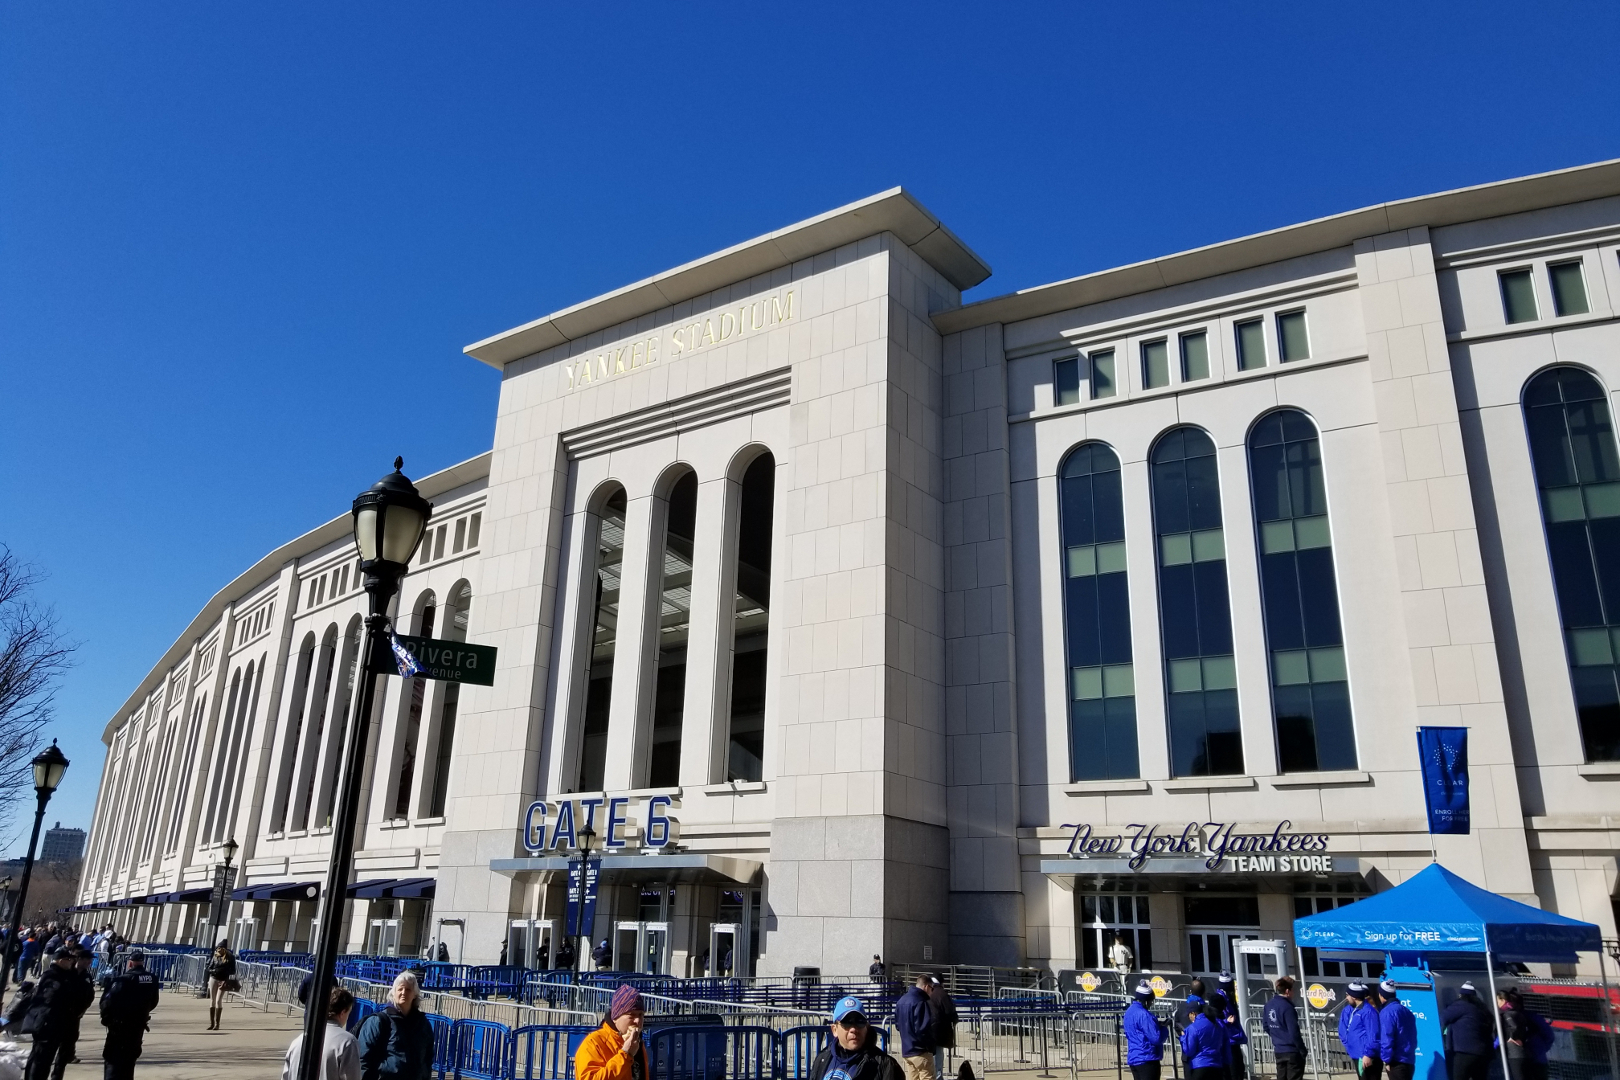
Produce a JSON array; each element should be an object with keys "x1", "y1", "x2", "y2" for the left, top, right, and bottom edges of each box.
[{"x1": 298, "y1": 458, "x2": 433, "y2": 1080}]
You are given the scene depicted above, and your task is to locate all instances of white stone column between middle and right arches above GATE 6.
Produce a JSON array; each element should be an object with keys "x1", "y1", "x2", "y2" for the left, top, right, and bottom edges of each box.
[{"x1": 680, "y1": 476, "x2": 740, "y2": 787}]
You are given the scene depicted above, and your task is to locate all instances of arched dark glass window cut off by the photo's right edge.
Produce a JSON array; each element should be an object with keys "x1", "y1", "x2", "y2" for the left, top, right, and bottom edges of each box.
[{"x1": 1524, "y1": 368, "x2": 1620, "y2": 761}]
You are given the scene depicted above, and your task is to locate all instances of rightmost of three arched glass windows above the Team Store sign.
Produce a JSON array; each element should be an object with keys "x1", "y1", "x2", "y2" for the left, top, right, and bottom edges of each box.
[{"x1": 1249, "y1": 408, "x2": 1356, "y2": 772}]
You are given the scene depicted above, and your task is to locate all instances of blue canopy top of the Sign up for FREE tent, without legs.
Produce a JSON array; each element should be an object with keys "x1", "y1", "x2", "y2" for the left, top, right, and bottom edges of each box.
[{"x1": 1294, "y1": 863, "x2": 1602, "y2": 963}]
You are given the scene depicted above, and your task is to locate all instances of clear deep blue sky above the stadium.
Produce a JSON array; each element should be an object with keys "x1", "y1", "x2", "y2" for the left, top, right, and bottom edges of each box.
[{"x1": 0, "y1": 0, "x2": 1620, "y2": 848}]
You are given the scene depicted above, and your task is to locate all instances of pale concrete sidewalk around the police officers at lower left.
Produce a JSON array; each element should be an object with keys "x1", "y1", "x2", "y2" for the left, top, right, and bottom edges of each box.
[{"x1": 51, "y1": 989, "x2": 303, "y2": 1080}]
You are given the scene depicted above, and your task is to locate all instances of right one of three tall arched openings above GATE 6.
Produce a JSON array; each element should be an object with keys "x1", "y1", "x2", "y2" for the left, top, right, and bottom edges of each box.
[{"x1": 726, "y1": 453, "x2": 776, "y2": 780}]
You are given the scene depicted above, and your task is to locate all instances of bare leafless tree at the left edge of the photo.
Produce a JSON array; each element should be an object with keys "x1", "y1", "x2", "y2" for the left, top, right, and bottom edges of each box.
[{"x1": 0, "y1": 544, "x2": 78, "y2": 819}]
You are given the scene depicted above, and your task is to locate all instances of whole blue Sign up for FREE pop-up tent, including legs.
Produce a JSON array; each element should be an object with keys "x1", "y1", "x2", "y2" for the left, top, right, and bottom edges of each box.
[{"x1": 1294, "y1": 863, "x2": 1620, "y2": 1078}]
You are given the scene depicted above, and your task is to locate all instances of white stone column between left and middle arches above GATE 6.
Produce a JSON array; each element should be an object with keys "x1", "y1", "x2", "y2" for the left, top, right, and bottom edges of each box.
[{"x1": 598, "y1": 495, "x2": 663, "y2": 790}]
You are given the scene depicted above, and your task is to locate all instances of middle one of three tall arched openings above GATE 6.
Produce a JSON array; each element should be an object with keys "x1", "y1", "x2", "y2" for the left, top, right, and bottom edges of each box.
[{"x1": 646, "y1": 471, "x2": 698, "y2": 787}]
